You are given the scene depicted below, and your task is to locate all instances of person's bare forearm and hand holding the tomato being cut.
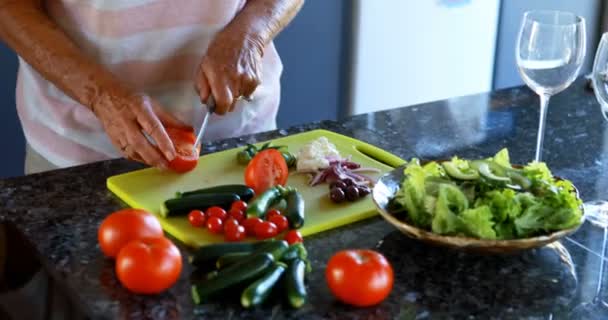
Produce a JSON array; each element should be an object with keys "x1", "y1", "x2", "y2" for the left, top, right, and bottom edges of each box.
[{"x1": 0, "y1": 0, "x2": 180, "y2": 167}]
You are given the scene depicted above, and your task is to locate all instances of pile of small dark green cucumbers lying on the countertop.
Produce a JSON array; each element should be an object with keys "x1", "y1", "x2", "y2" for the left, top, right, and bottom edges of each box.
[{"x1": 190, "y1": 240, "x2": 311, "y2": 308}]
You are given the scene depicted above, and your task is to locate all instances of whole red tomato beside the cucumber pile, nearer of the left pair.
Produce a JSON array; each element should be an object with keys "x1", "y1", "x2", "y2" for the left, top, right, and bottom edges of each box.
[{"x1": 116, "y1": 237, "x2": 182, "y2": 294}]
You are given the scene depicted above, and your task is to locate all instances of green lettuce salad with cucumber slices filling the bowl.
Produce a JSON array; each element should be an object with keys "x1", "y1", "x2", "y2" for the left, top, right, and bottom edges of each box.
[{"x1": 391, "y1": 149, "x2": 582, "y2": 240}]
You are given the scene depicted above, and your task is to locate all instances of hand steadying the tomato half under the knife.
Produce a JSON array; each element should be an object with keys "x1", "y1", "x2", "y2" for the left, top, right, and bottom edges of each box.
[{"x1": 93, "y1": 94, "x2": 187, "y2": 169}]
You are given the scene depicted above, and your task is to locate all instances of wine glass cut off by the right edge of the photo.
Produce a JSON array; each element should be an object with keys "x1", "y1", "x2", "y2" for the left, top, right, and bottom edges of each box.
[{"x1": 573, "y1": 33, "x2": 608, "y2": 319}]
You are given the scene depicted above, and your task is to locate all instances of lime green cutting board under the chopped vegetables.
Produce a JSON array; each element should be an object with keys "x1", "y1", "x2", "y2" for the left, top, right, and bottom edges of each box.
[{"x1": 107, "y1": 130, "x2": 404, "y2": 247}]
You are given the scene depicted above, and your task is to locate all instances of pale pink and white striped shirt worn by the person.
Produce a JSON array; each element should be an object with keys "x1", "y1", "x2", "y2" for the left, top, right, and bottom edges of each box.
[{"x1": 16, "y1": 0, "x2": 283, "y2": 167}]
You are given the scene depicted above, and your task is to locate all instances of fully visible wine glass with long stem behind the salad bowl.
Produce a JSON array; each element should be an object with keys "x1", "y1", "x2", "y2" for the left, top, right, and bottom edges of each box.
[{"x1": 515, "y1": 10, "x2": 586, "y2": 161}]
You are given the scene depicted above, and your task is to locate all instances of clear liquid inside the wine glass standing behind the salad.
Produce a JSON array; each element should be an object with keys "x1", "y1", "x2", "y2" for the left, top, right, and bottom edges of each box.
[{"x1": 518, "y1": 59, "x2": 579, "y2": 95}]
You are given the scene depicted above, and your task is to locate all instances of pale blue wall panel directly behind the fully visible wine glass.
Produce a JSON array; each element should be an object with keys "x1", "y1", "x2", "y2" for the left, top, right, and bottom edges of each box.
[{"x1": 494, "y1": 0, "x2": 602, "y2": 89}]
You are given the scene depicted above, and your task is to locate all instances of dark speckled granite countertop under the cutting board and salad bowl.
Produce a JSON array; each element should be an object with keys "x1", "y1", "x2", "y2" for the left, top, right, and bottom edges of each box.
[{"x1": 0, "y1": 80, "x2": 608, "y2": 319}]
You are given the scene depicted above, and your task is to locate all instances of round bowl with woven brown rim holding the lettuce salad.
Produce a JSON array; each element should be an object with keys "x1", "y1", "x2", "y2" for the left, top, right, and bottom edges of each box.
[{"x1": 372, "y1": 166, "x2": 584, "y2": 253}]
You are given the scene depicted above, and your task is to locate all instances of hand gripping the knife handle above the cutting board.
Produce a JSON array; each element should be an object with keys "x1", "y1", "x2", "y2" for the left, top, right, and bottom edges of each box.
[{"x1": 195, "y1": 33, "x2": 263, "y2": 115}]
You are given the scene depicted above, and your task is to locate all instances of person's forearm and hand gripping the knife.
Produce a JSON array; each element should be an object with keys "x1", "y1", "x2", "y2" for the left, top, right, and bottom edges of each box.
[{"x1": 197, "y1": 0, "x2": 304, "y2": 114}]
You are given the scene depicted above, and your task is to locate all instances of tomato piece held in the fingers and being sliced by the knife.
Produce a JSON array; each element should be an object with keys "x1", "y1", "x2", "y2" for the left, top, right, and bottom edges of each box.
[{"x1": 165, "y1": 128, "x2": 200, "y2": 173}]
